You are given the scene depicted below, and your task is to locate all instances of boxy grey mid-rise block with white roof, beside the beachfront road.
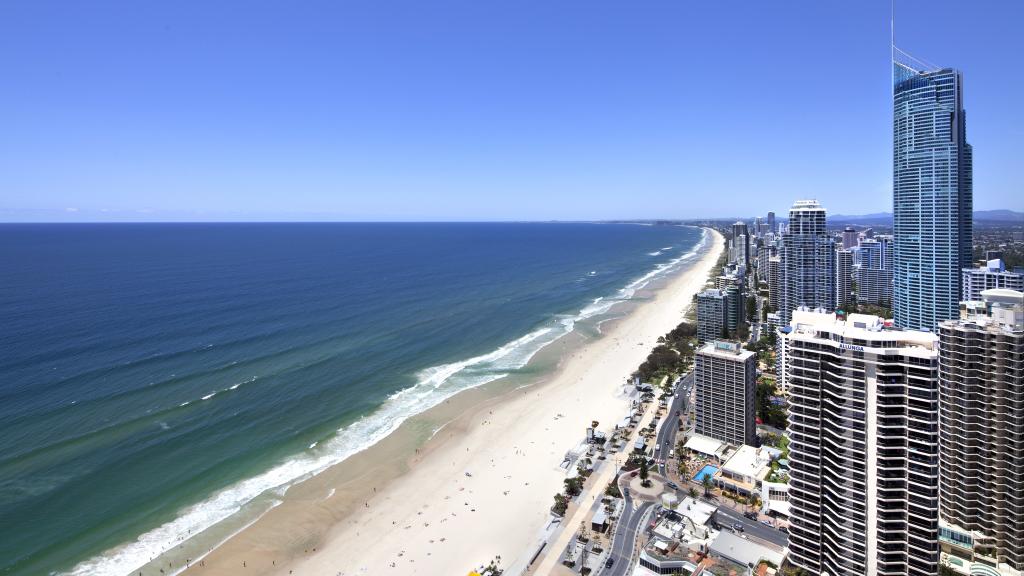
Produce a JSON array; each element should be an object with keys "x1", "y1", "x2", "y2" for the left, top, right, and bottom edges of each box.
[{"x1": 693, "y1": 340, "x2": 757, "y2": 446}]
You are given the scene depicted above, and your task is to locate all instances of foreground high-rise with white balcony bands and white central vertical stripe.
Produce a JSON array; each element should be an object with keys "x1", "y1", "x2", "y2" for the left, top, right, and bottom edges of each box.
[{"x1": 779, "y1": 311, "x2": 939, "y2": 576}]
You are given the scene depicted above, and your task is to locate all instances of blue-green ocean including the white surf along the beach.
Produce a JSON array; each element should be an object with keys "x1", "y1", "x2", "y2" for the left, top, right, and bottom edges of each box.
[{"x1": 0, "y1": 223, "x2": 702, "y2": 576}]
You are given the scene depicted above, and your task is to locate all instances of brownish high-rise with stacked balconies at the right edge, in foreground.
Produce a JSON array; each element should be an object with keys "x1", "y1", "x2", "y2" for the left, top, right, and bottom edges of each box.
[{"x1": 939, "y1": 289, "x2": 1024, "y2": 570}]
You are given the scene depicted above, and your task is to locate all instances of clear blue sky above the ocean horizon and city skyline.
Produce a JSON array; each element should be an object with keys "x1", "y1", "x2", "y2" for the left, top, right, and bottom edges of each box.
[{"x1": 0, "y1": 0, "x2": 1024, "y2": 221}]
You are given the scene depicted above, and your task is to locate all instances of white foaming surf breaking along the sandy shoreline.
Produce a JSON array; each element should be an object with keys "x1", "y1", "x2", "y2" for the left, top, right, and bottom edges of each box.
[{"x1": 61, "y1": 226, "x2": 708, "y2": 576}]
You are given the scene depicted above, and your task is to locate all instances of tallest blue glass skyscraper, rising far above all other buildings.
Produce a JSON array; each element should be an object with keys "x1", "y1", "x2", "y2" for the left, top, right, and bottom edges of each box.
[{"x1": 893, "y1": 58, "x2": 973, "y2": 331}]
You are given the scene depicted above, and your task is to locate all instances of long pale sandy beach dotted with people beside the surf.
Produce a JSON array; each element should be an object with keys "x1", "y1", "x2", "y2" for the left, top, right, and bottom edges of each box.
[{"x1": 185, "y1": 226, "x2": 723, "y2": 575}]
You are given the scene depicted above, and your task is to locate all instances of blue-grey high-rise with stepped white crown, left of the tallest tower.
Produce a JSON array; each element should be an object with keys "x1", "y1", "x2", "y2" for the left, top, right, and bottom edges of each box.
[{"x1": 778, "y1": 200, "x2": 836, "y2": 323}]
